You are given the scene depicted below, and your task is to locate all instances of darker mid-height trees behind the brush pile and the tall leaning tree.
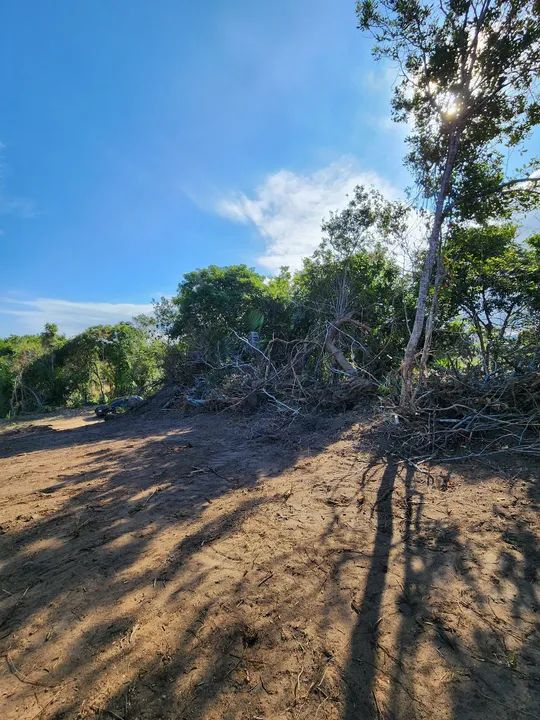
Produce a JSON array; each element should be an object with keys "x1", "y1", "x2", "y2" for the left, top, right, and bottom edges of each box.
[{"x1": 153, "y1": 204, "x2": 540, "y2": 403}]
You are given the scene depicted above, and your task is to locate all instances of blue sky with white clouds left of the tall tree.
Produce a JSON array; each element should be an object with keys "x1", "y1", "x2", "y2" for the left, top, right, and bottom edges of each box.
[{"x1": 0, "y1": 0, "x2": 536, "y2": 335}]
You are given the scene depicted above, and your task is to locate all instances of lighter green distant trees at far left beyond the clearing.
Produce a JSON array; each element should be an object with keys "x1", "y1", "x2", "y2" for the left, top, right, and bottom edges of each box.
[{"x1": 0, "y1": 321, "x2": 164, "y2": 416}]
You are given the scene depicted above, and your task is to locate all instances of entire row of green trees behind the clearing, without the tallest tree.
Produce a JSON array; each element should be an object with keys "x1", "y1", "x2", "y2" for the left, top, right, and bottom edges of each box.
[{"x1": 0, "y1": 187, "x2": 540, "y2": 415}]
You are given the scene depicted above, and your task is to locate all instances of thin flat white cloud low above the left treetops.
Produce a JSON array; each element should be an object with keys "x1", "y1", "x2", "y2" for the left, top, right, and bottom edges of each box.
[{"x1": 0, "y1": 297, "x2": 152, "y2": 335}]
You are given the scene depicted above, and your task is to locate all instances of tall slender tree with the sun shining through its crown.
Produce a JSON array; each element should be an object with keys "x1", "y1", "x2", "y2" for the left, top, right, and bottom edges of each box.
[{"x1": 357, "y1": 0, "x2": 540, "y2": 406}]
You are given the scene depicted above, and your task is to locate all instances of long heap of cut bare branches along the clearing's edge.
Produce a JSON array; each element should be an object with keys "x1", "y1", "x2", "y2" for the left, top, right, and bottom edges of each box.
[{"x1": 153, "y1": 323, "x2": 540, "y2": 464}]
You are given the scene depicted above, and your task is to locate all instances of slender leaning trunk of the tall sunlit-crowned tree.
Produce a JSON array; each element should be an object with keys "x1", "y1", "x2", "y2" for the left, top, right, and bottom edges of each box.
[{"x1": 400, "y1": 129, "x2": 461, "y2": 409}]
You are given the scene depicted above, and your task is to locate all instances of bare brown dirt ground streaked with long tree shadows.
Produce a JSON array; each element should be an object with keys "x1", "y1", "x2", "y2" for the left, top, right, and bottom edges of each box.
[{"x1": 0, "y1": 411, "x2": 540, "y2": 720}]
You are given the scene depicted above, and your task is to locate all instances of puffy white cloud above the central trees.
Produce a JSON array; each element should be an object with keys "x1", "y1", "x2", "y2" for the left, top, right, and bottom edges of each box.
[{"x1": 216, "y1": 158, "x2": 399, "y2": 272}]
